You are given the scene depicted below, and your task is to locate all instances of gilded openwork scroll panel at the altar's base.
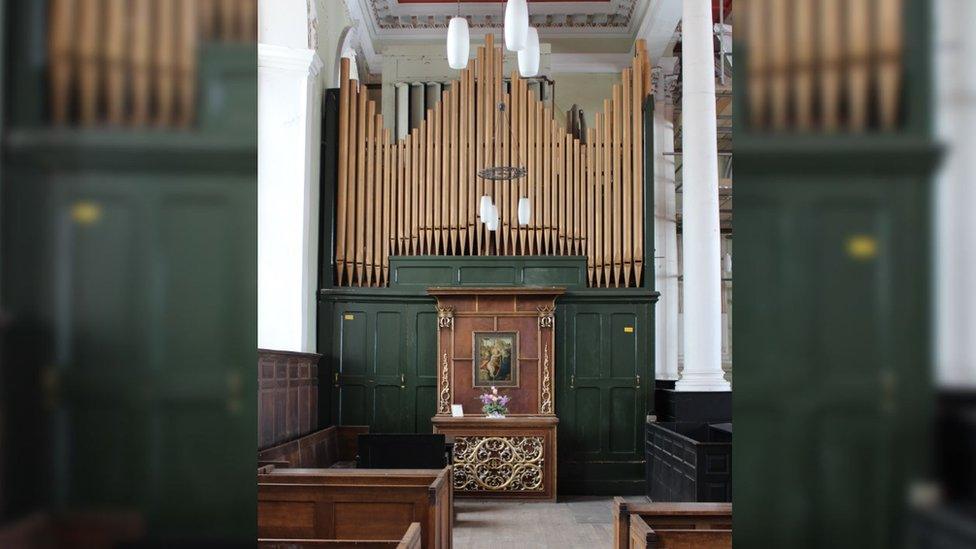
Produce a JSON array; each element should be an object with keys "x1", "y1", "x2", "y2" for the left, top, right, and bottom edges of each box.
[{"x1": 454, "y1": 436, "x2": 545, "y2": 492}]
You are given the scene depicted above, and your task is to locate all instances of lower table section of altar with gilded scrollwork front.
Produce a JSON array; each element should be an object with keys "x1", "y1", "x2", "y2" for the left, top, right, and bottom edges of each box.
[{"x1": 432, "y1": 416, "x2": 559, "y2": 500}]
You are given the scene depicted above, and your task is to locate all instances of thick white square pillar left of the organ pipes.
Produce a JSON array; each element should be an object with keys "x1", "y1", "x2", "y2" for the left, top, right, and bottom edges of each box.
[{"x1": 258, "y1": 44, "x2": 322, "y2": 352}]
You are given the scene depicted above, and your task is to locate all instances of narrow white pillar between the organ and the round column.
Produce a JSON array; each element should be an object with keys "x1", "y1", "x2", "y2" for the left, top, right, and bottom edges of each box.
[{"x1": 653, "y1": 64, "x2": 679, "y2": 381}]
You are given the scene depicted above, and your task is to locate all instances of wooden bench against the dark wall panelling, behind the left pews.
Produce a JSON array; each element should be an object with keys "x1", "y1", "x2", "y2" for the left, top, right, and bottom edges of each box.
[{"x1": 258, "y1": 425, "x2": 369, "y2": 468}]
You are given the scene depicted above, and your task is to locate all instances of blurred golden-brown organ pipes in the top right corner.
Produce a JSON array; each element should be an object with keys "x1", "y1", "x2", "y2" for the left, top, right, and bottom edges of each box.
[{"x1": 736, "y1": 0, "x2": 905, "y2": 133}]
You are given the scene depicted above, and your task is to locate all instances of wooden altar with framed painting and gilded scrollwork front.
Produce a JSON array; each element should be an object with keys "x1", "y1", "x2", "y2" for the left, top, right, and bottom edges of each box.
[{"x1": 428, "y1": 287, "x2": 564, "y2": 500}]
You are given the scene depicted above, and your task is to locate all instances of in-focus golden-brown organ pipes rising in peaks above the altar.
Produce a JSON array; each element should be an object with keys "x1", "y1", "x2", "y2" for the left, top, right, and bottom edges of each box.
[{"x1": 335, "y1": 35, "x2": 651, "y2": 287}]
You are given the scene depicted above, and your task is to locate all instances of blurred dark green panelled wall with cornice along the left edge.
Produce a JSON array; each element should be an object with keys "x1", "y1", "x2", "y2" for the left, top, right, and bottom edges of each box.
[{"x1": 0, "y1": 2, "x2": 257, "y2": 542}]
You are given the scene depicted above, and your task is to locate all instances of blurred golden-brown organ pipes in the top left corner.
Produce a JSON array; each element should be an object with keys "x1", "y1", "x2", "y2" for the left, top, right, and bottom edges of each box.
[{"x1": 48, "y1": 0, "x2": 257, "y2": 127}]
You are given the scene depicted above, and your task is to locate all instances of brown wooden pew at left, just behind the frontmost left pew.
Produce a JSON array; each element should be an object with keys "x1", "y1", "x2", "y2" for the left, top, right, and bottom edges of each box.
[{"x1": 258, "y1": 467, "x2": 454, "y2": 549}]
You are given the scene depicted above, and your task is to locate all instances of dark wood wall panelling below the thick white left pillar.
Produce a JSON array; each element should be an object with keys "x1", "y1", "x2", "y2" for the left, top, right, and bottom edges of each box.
[{"x1": 258, "y1": 349, "x2": 321, "y2": 448}]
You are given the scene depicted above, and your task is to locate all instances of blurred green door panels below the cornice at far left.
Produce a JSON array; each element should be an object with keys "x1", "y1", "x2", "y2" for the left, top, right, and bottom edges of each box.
[{"x1": 4, "y1": 170, "x2": 256, "y2": 539}]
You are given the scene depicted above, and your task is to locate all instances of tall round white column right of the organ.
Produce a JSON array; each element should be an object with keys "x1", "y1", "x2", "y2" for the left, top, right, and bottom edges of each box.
[{"x1": 675, "y1": 0, "x2": 730, "y2": 391}]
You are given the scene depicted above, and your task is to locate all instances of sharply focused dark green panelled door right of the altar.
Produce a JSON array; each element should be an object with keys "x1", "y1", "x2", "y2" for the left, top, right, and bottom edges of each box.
[{"x1": 556, "y1": 303, "x2": 653, "y2": 494}]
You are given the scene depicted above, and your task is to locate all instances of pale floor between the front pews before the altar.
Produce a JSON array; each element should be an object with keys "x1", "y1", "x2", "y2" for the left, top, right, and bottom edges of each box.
[{"x1": 454, "y1": 497, "x2": 646, "y2": 549}]
